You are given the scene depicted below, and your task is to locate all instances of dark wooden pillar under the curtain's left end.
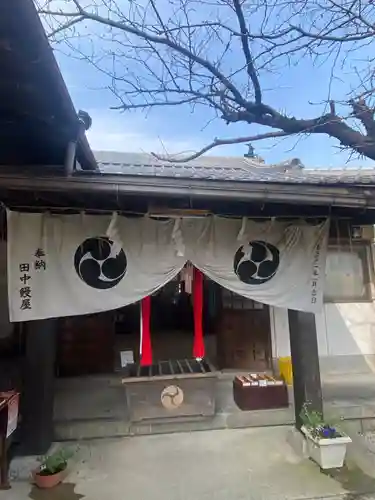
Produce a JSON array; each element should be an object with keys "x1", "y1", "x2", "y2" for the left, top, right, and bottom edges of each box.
[{"x1": 20, "y1": 319, "x2": 57, "y2": 455}]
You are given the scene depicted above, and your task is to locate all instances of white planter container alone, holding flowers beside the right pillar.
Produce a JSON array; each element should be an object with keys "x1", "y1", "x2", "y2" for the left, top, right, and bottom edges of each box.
[{"x1": 301, "y1": 426, "x2": 352, "y2": 469}]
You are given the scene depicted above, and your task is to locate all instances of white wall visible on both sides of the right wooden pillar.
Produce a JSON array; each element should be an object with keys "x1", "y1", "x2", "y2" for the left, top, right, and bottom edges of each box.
[{"x1": 271, "y1": 303, "x2": 375, "y2": 376}]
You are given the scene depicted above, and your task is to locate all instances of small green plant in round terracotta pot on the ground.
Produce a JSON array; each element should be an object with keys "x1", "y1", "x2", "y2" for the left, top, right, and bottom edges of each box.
[{"x1": 34, "y1": 448, "x2": 73, "y2": 488}]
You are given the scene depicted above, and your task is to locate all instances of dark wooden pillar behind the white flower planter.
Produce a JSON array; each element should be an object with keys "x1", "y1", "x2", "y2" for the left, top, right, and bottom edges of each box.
[{"x1": 288, "y1": 310, "x2": 323, "y2": 429}]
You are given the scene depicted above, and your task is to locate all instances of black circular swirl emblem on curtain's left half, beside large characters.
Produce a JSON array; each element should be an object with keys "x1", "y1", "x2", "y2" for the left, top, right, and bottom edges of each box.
[{"x1": 74, "y1": 236, "x2": 127, "y2": 290}]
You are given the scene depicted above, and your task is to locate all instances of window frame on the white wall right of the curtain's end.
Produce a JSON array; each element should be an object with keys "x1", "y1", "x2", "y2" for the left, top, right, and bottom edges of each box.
[{"x1": 323, "y1": 240, "x2": 373, "y2": 304}]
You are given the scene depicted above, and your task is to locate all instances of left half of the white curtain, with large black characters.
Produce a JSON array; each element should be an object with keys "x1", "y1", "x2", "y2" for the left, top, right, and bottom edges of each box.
[{"x1": 7, "y1": 211, "x2": 186, "y2": 321}]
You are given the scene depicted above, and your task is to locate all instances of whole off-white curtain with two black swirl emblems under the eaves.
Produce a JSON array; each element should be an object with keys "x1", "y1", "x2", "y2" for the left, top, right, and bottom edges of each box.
[{"x1": 7, "y1": 210, "x2": 329, "y2": 321}]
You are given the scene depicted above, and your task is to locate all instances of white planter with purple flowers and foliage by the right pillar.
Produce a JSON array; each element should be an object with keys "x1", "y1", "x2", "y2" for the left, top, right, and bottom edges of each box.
[{"x1": 301, "y1": 405, "x2": 352, "y2": 469}]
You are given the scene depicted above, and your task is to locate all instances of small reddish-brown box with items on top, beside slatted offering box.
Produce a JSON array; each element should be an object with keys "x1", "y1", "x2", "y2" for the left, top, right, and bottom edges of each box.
[{"x1": 233, "y1": 374, "x2": 289, "y2": 411}]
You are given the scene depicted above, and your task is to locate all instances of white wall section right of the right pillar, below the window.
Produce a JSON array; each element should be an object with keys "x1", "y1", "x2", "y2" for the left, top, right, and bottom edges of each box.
[{"x1": 320, "y1": 303, "x2": 375, "y2": 374}]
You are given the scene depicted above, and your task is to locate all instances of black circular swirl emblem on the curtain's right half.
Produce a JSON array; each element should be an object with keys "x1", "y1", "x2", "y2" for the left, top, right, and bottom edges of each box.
[{"x1": 233, "y1": 241, "x2": 280, "y2": 285}]
